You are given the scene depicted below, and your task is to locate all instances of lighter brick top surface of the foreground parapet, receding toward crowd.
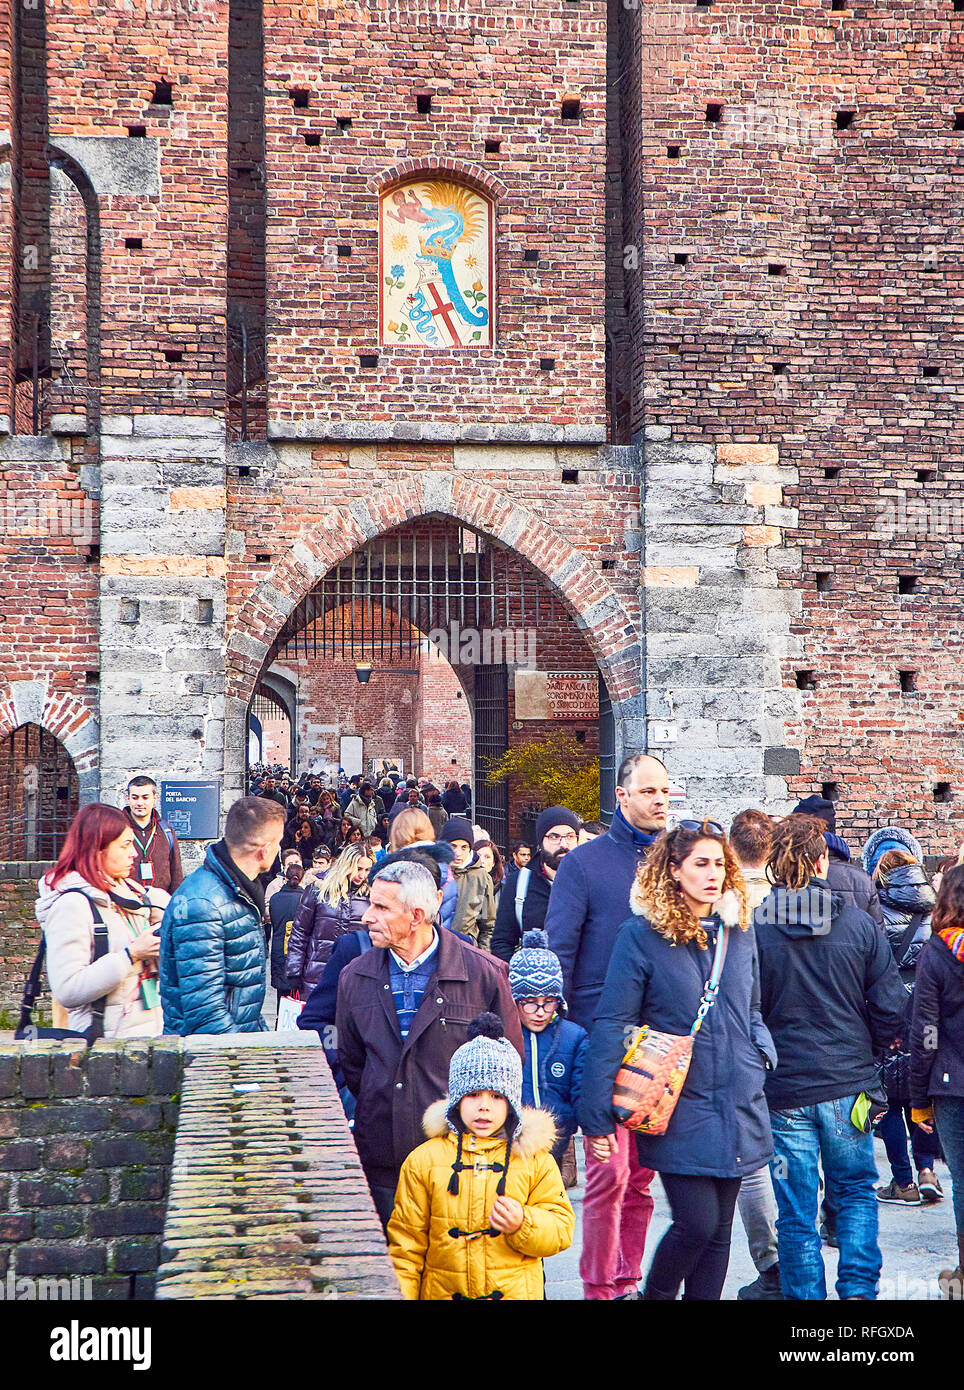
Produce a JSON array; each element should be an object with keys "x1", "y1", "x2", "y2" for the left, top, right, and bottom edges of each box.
[{"x1": 157, "y1": 1033, "x2": 400, "y2": 1300}]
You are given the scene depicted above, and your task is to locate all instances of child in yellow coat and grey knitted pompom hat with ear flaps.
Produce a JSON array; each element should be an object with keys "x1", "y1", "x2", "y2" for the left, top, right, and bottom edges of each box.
[{"x1": 389, "y1": 1013, "x2": 575, "y2": 1301}]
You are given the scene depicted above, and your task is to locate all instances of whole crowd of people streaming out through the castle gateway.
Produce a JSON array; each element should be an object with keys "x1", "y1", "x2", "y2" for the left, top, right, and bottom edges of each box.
[{"x1": 22, "y1": 753, "x2": 964, "y2": 1301}]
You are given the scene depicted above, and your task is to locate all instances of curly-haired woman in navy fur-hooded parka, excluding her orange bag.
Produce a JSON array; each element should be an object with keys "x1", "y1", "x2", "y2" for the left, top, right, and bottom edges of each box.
[{"x1": 579, "y1": 820, "x2": 776, "y2": 1300}]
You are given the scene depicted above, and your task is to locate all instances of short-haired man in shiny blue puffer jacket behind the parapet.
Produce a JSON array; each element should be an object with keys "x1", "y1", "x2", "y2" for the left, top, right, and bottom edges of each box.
[{"x1": 160, "y1": 796, "x2": 285, "y2": 1037}]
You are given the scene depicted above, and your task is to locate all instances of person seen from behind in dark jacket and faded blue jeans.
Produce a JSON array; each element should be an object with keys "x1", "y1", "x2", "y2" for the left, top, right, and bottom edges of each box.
[{"x1": 753, "y1": 815, "x2": 907, "y2": 1300}]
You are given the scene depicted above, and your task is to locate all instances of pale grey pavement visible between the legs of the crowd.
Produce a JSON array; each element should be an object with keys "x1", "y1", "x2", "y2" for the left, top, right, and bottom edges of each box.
[{"x1": 546, "y1": 1137, "x2": 957, "y2": 1300}]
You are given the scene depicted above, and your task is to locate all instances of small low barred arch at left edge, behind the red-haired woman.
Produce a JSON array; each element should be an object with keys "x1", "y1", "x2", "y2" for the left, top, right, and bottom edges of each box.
[{"x1": 0, "y1": 724, "x2": 81, "y2": 863}]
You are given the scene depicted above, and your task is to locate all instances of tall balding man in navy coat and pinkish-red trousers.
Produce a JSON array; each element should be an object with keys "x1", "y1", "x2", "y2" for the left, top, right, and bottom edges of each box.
[{"x1": 547, "y1": 753, "x2": 670, "y2": 1300}]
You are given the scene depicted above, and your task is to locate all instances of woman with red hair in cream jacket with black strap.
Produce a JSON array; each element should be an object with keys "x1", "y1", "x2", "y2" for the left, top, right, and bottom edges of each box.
[{"x1": 36, "y1": 802, "x2": 168, "y2": 1038}]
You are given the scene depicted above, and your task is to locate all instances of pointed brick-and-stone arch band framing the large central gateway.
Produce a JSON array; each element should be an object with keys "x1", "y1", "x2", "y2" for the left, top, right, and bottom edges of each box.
[{"x1": 226, "y1": 474, "x2": 642, "y2": 708}]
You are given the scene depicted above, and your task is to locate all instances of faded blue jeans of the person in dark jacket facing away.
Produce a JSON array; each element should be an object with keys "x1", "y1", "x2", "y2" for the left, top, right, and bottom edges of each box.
[{"x1": 770, "y1": 1095, "x2": 882, "y2": 1301}]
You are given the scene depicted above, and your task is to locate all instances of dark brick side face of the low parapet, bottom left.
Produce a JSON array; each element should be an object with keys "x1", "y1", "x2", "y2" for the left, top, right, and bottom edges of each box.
[{"x1": 0, "y1": 1038, "x2": 183, "y2": 1300}]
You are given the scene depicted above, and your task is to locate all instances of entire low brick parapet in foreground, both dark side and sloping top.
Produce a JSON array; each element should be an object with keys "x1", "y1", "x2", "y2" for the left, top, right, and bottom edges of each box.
[{"x1": 0, "y1": 1033, "x2": 400, "y2": 1300}]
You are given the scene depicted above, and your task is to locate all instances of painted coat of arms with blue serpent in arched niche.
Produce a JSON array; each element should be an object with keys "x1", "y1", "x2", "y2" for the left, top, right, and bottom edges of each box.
[{"x1": 378, "y1": 179, "x2": 493, "y2": 348}]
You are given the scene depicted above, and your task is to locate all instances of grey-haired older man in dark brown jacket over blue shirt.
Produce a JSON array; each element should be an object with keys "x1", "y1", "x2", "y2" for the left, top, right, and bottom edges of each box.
[{"x1": 335, "y1": 862, "x2": 525, "y2": 1225}]
